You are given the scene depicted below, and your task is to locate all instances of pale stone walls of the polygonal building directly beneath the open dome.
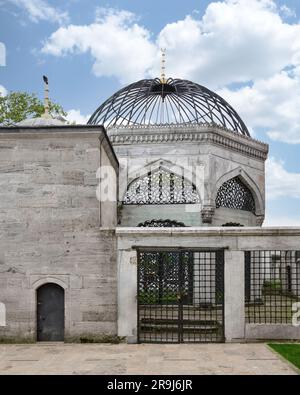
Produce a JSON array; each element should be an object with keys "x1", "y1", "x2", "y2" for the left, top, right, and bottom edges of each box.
[{"x1": 108, "y1": 125, "x2": 268, "y2": 226}]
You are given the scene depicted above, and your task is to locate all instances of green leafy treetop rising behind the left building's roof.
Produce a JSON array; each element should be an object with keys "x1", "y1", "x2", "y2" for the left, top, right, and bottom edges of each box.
[{"x1": 0, "y1": 92, "x2": 67, "y2": 126}]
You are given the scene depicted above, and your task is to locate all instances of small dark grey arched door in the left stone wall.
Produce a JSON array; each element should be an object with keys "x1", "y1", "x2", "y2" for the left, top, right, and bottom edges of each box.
[{"x1": 37, "y1": 283, "x2": 65, "y2": 341}]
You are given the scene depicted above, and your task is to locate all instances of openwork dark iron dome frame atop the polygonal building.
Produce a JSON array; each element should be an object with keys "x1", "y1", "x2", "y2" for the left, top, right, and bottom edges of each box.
[{"x1": 88, "y1": 78, "x2": 250, "y2": 137}]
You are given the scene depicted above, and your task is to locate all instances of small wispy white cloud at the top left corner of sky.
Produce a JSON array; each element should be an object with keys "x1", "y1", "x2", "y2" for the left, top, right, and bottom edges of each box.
[{"x1": 8, "y1": 0, "x2": 69, "y2": 24}]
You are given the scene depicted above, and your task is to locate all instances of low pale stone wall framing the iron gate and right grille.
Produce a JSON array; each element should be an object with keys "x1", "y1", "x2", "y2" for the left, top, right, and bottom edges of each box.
[{"x1": 116, "y1": 227, "x2": 300, "y2": 342}]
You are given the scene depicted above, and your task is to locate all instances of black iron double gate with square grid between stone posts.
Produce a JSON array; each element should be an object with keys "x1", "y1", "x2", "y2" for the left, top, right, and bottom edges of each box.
[{"x1": 138, "y1": 250, "x2": 224, "y2": 343}]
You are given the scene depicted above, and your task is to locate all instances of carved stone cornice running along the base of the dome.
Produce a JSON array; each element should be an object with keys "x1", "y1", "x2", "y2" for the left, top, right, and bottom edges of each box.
[{"x1": 108, "y1": 125, "x2": 269, "y2": 160}]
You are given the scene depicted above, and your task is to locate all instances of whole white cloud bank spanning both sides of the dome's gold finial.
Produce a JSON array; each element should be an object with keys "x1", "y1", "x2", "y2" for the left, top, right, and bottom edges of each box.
[{"x1": 43, "y1": 0, "x2": 300, "y2": 88}]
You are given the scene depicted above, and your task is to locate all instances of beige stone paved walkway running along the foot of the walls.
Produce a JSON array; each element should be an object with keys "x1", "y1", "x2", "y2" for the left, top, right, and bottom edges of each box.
[{"x1": 0, "y1": 343, "x2": 296, "y2": 375}]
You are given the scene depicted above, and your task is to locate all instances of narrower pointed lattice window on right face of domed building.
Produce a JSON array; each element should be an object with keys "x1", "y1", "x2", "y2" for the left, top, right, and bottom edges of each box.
[{"x1": 216, "y1": 177, "x2": 255, "y2": 214}]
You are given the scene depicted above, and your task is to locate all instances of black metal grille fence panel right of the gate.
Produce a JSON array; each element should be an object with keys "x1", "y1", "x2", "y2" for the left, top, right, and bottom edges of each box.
[{"x1": 245, "y1": 250, "x2": 300, "y2": 324}]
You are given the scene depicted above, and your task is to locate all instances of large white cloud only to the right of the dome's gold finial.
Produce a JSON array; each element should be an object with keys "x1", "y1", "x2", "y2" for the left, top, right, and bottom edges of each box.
[{"x1": 158, "y1": 0, "x2": 300, "y2": 88}]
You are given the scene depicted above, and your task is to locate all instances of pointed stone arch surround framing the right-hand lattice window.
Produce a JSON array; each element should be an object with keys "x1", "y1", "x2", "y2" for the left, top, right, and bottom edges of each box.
[{"x1": 213, "y1": 167, "x2": 264, "y2": 215}]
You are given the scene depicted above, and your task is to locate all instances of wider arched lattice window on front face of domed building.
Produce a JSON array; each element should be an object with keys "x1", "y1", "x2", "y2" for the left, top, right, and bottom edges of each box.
[{"x1": 123, "y1": 168, "x2": 200, "y2": 204}]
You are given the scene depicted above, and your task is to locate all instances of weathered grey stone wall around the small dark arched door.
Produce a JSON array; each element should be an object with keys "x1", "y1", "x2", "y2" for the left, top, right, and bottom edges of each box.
[{"x1": 0, "y1": 127, "x2": 117, "y2": 341}]
